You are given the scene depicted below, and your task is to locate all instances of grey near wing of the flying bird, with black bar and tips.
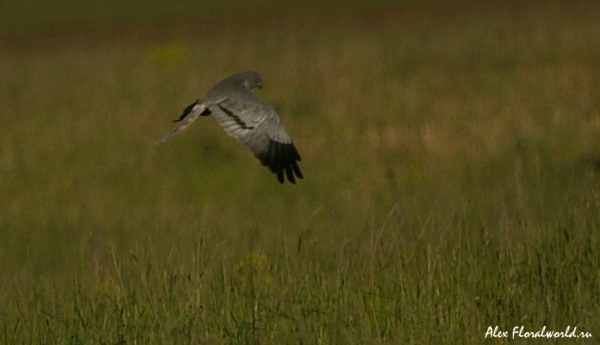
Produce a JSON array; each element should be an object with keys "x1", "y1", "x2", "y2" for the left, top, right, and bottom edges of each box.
[{"x1": 206, "y1": 88, "x2": 303, "y2": 184}]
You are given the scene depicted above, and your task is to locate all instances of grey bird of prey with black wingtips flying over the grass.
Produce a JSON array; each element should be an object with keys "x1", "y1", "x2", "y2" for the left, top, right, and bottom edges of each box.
[{"x1": 156, "y1": 71, "x2": 303, "y2": 184}]
